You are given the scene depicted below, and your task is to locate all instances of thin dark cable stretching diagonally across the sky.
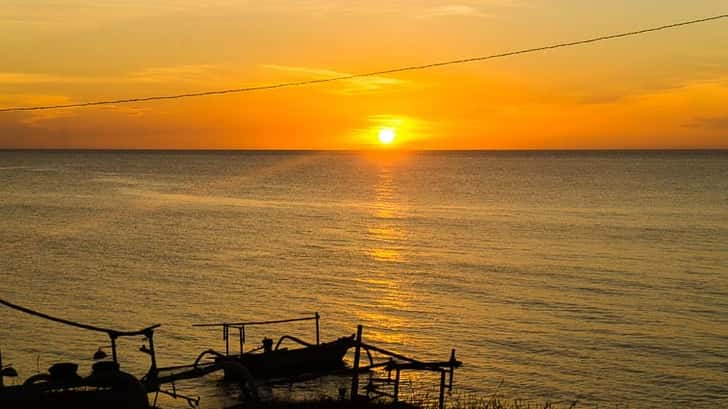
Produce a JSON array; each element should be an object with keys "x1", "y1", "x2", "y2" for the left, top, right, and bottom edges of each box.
[{"x1": 0, "y1": 14, "x2": 728, "y2": 112}]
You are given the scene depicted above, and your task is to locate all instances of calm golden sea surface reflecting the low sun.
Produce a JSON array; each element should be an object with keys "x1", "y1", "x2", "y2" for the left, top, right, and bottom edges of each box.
[{"x1": 0, "y1": 151, "x2": 728, "y2": 408}]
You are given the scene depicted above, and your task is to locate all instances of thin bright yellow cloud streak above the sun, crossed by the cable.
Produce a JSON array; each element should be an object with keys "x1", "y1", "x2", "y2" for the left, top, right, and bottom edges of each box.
[{"x1": 263, "y1": 64, "x2": 407, "y2": 95}]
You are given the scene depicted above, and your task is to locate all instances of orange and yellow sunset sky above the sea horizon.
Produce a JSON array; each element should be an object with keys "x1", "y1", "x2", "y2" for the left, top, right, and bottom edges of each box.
[{"x1": 0, "y1": 0, "x2": 728, "y2": 149}]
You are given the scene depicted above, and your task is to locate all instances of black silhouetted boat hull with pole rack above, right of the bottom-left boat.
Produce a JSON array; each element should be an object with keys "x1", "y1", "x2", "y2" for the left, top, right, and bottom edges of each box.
[{"x1": 195, "y1": 313, "x2": 354, "y2": 380}]
